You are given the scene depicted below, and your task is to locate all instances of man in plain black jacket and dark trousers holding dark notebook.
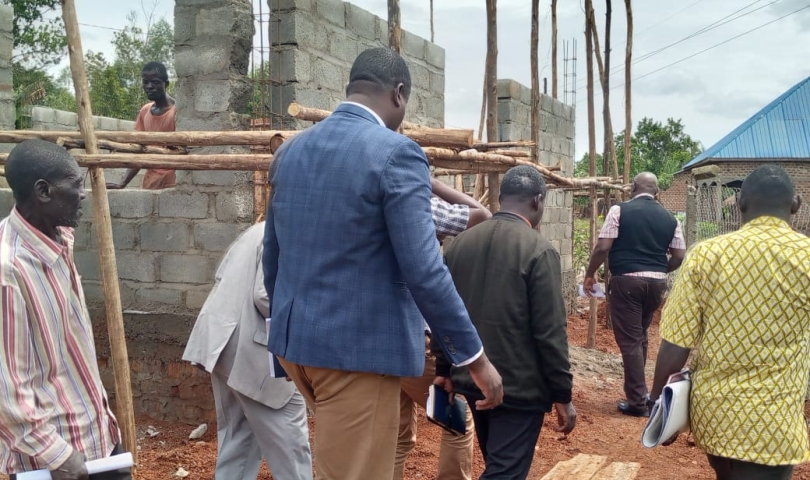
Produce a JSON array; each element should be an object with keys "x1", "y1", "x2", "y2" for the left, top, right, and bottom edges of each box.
[{"x1": 433, "y1": 166, "x2": 576, "y2": 480}]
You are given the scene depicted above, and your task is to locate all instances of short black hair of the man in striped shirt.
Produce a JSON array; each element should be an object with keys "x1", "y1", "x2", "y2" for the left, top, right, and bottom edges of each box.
[{"x1": 6, "y1": 139, "x2": 79, "y2": 202}]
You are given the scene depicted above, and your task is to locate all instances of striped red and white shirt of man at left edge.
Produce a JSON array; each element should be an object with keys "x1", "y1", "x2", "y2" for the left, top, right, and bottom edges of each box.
[{"x1": 0, "y1": 208, "x2": 121, "y2": 473}]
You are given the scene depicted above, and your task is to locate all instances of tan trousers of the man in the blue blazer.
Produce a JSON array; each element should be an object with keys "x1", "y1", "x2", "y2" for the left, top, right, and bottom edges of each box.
[{"x1": 279, "y1": 359, "x2": 400, "y2": 480}]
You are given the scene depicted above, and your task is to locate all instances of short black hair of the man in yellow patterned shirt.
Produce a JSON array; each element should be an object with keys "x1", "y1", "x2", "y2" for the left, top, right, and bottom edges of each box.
[{"x1": 740, "y1": 164, "x2": 794, "y2": 210}]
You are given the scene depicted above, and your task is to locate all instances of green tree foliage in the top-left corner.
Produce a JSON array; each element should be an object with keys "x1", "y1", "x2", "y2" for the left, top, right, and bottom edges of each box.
[{"x1": 0, "y1": 0, "x2": 67, "y2": 68}]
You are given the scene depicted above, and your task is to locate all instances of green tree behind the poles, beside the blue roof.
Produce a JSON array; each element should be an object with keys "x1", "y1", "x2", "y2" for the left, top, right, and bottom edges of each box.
[{"x1": 574, "y1": 117, "x2": 703, "y2": 189}]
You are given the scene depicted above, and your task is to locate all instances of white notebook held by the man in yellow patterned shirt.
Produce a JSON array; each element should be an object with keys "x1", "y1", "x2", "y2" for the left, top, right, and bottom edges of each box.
[{"x1": 641, "y1": 369, "x2": 692, "y2": 448}]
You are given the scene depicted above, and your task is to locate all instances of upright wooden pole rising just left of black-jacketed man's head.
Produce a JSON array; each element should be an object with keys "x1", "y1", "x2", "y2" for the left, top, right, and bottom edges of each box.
[{"x1": 485, "y1": 0, "x2": 501, "y2": 213}]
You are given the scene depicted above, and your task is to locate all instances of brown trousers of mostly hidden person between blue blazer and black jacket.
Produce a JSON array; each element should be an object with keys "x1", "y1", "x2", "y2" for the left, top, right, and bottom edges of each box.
[{"x1": 393, "y1": 340, "x2": 475, "y2": 480}]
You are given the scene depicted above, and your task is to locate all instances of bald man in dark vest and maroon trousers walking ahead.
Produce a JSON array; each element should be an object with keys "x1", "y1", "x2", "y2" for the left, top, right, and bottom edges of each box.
[{"x1": 584, "y1": 172, "x2": 686, "y2": 417}]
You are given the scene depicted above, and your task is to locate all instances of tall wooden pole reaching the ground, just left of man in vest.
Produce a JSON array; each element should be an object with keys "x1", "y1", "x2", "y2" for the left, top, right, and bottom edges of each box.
[{"x1": 585, "y1": 0, "x2": 598, "y2": 348}]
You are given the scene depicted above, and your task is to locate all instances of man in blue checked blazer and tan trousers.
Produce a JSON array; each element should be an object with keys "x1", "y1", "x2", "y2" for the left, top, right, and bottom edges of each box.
[{"x1": 264, "y1": 48, "x2": 503, "y2": 480}]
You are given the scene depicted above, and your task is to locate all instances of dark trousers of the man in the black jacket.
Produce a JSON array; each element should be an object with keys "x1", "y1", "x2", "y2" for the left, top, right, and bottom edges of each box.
[{"x1": 470, "y1": 402, "x2": 545, "y2": 480}]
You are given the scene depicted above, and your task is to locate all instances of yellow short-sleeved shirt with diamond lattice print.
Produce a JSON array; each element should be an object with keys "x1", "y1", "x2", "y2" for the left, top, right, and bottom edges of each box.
[{"x1": 661, "y1": 217, "x2": 810, "y2": 465}]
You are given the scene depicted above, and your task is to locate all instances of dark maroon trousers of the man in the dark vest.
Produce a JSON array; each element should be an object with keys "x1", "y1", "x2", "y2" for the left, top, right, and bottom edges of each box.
[{"x1": 609, "y1": 275, "x2": 667, "y2": 408}]
